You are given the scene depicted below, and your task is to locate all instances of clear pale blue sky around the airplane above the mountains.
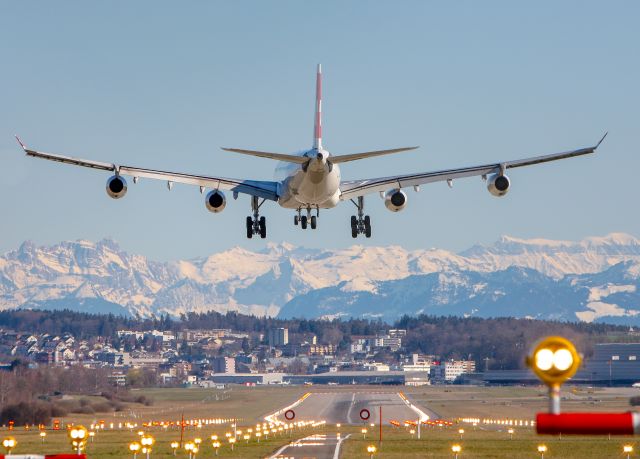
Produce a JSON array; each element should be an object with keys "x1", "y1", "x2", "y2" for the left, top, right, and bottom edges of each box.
[{"x1": 0, "y1": 1, "x2": 640, "y2": 260}]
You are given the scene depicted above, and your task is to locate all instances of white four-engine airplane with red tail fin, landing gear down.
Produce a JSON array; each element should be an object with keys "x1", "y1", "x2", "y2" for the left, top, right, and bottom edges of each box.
[{"x1": 16, "y1": 65, "x2": 607, "y2": 243}]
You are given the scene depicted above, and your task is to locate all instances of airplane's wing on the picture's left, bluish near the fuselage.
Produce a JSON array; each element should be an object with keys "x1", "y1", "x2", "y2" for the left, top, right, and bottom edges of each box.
[{"x1": 16, "y1": 136, "x2": 279, "y2": 201}]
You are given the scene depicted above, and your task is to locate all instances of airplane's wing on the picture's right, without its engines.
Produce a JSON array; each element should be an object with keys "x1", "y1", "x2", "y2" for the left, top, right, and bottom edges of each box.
[{"x1": 340, "y1": 133, "x2": 607, "y2": 200}]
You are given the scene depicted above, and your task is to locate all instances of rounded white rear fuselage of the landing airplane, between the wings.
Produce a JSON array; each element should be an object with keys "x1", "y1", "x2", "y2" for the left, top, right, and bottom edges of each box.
[{"x1": 276, "y1": 148, "x2": 340, "y2": 209}]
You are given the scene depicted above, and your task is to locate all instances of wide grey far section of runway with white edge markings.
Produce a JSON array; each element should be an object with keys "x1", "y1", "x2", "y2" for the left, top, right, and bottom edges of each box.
[{"x1": 278, "y1": 391, "x2": 433, "y2": 424}]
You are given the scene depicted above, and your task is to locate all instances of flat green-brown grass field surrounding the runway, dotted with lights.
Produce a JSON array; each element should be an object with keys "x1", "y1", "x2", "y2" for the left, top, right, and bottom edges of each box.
[{"x1": 0, "y1": 386, "x2": 640, "y2": 459}]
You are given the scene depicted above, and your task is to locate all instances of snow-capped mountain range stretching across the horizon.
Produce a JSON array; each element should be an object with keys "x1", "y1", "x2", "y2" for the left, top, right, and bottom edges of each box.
[{"x1": 0, "y1": 233, "x2": 640, "y2": 324}]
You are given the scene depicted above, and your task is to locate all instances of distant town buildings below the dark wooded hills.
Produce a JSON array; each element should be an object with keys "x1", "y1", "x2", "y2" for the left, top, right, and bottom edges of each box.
[{"x1": 0, "y1": 313, "x2": 640, "y2": 388}]
